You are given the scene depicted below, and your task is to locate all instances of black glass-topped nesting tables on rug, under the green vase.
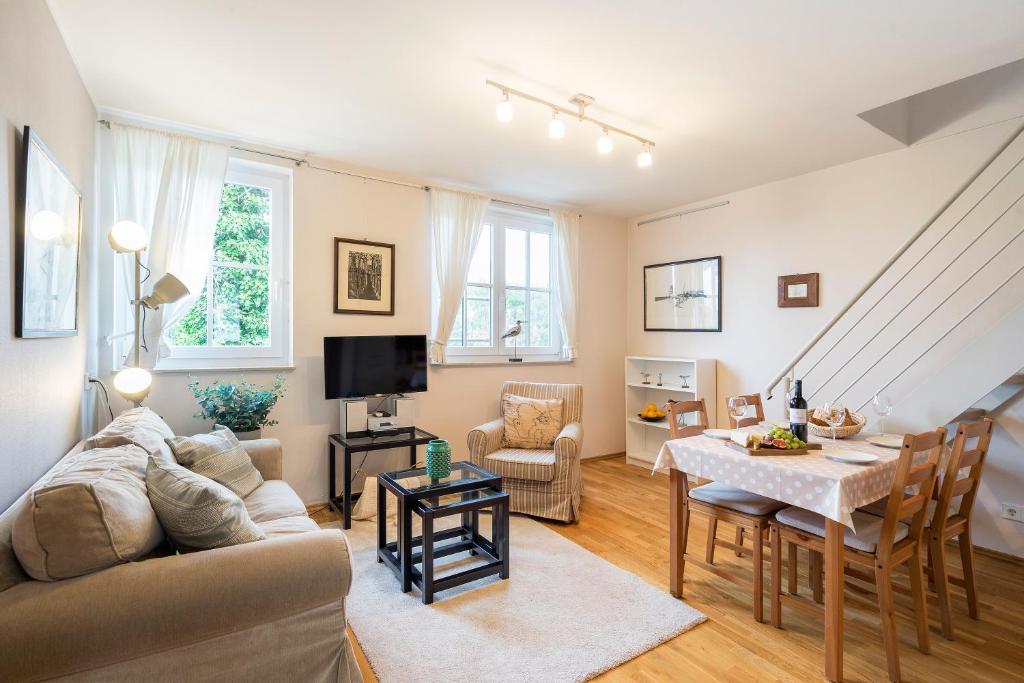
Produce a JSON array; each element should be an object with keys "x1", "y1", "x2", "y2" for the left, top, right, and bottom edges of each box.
[{"x1": 377, "y1": 461, "x2": 509, "y2": 604}]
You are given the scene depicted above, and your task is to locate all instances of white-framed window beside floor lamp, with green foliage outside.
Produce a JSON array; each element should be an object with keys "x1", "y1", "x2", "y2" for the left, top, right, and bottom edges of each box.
[{"x1": 159, "y1": 158, "x2": 292, "y2": 369}]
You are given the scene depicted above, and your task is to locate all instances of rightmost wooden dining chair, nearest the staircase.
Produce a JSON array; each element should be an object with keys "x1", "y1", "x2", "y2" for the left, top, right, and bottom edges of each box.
[{"x1": 927, "y1": 418, "x2": 992, "y2": 640}]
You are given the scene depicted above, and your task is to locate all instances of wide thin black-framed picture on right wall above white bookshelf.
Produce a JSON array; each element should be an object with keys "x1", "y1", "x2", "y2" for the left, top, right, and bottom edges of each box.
[{"x1": 643, "y1": 256, "x2": 722, "y2": 332}]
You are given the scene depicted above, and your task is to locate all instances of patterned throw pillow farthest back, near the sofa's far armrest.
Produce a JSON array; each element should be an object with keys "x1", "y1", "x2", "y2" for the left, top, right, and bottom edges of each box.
[{"x1": 167, "y1": 425, "x2": 263, "y2": 498}]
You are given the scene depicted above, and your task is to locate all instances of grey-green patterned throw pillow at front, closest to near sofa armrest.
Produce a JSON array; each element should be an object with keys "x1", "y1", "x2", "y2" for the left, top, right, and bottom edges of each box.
[{"x1": 145, "y1": 457, "x2": 263, "y2": 550}]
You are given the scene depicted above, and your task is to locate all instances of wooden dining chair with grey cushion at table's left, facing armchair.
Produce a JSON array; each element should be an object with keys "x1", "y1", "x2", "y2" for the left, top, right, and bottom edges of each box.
[{"x1": 667, "y1": 399, "x2": 784, "y2": 622}]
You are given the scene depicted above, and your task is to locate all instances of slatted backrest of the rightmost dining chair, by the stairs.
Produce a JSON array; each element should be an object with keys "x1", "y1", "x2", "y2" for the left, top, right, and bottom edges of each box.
[{"x1": 932, "y1": 418, "x2": 993, "y2": 533}]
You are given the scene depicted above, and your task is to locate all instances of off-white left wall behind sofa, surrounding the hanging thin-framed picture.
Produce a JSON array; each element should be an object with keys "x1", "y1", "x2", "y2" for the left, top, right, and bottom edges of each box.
[{"x1": 0, "y1": 0, "x2": 95, "y2": 510}]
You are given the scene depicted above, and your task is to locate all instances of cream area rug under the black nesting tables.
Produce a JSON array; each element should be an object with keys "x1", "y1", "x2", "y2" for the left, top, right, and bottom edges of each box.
[{"x1": 325, "y1": 515, "x2": 707, "y2": 683}]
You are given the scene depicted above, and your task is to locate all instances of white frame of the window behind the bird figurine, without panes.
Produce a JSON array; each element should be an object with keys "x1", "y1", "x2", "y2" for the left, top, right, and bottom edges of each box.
[{"x1": 447, "y1": 205, "x2": 562, "y2": 364}]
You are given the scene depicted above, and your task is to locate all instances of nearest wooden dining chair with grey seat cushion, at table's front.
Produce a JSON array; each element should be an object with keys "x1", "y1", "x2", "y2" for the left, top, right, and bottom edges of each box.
[{"x1": 771, "y1": 427, "x2": 946, "y2": 681}]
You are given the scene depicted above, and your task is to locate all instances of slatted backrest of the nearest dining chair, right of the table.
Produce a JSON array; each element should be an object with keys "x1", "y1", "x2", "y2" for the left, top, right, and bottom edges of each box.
[{"x1": 877, "y1": 427, "x2": 946, "y2": 556}]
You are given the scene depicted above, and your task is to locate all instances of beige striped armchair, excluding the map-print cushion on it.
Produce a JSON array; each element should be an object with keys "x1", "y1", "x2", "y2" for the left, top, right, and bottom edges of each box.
[{"x1": 468, "y1": 382, "x2": 583, "y2": 522}]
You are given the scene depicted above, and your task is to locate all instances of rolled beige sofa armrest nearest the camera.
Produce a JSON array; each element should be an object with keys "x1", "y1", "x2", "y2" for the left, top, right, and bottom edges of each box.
[{"x1": 0, "y1": 529, "x2": 352, "y2": 681}]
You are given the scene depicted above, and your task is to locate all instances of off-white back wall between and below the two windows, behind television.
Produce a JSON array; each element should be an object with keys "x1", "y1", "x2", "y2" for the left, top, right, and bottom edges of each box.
[{"x1": 117, "y1": 152, "x2": 626, "y2": 503}]
